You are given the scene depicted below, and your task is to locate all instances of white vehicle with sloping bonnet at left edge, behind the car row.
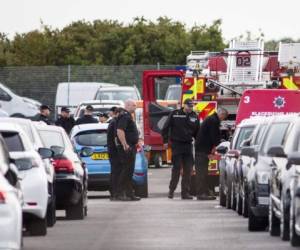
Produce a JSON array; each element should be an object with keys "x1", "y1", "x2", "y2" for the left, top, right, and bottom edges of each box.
[{"x1": 0, "y1": 83, "x2": 41, "y2": 117}]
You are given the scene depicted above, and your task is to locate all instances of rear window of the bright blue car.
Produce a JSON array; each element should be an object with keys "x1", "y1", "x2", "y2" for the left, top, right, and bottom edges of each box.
[{"x1": 75, "y1": 130, "x2": 107, "y2": 146}]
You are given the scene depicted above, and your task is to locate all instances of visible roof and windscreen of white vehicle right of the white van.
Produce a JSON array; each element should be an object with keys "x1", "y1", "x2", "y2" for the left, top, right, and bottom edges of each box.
[{"x1": 94, "y1": 86, "x2": 141, "y2": 102}]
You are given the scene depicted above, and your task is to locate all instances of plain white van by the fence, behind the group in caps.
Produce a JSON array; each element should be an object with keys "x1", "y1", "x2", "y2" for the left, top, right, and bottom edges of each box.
[{"x1": 55, "y1": 82, "x2": 118, "y2": 114}]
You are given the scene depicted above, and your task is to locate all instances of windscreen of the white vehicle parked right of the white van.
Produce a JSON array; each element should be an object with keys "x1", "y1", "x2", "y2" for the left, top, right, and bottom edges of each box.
[{"x1": 96, "y1": 88, "x2": 139, "y2": 102}]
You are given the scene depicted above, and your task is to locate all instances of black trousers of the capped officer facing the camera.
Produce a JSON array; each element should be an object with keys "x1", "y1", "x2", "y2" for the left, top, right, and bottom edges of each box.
[{"x1": 169, "y1": 152, "x2": 194, "y2": 195}]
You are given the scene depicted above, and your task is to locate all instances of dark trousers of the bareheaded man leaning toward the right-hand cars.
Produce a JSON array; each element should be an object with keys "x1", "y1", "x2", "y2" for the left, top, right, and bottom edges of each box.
[{"x1": 195, "y1": 152, "x2": 209, "y2": 195}]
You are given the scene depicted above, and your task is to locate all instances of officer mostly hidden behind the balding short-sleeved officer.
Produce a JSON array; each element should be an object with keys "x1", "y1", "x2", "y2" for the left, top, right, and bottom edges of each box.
[{"x1": 107, "y1": 108, "x2": 121, "y2": 201}]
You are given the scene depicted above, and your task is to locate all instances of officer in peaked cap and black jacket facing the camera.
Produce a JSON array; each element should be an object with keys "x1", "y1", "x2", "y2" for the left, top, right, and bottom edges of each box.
[{"x1": 162, "y1": 99, "x2": 199, "y2": 199}]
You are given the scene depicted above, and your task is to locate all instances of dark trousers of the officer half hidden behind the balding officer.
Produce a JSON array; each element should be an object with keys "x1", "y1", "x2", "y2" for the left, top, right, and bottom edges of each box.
[{"x1": 108, "y1": 150, "x2": 121, "y2": 197}]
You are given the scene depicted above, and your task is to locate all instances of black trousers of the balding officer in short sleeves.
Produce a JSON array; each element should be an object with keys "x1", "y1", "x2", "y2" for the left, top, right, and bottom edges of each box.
[{"x1": 118, "y1": 146, "x2": 136, "y2": 196}]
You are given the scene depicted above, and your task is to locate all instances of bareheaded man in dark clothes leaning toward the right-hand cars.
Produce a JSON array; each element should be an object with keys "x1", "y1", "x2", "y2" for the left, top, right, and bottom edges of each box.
[{"x1": 195, "y1": 108, "x2": 228, "y2": 200}]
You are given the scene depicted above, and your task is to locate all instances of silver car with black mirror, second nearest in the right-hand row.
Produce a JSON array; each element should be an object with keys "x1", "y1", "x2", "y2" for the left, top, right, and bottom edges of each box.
[{"x1": 267, "y1": 116, "x2": 300, "y2": 242}]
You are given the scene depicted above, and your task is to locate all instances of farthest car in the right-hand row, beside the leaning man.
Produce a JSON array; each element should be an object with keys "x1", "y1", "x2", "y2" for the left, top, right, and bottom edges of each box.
[{"x1": 217, "y1": 119, "x2": 258, "y2": 209}]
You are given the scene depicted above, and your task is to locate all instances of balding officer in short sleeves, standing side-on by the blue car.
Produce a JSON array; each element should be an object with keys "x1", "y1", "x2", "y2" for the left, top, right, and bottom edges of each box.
[{"x1": 117, "y1": 100, "x2": 140, "y2": 201}]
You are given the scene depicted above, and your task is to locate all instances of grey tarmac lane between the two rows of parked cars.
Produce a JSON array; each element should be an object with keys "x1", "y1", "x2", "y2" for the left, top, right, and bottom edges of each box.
[{"x1": 24, "y1": 168, "x2": 293, "y2": 250}]
